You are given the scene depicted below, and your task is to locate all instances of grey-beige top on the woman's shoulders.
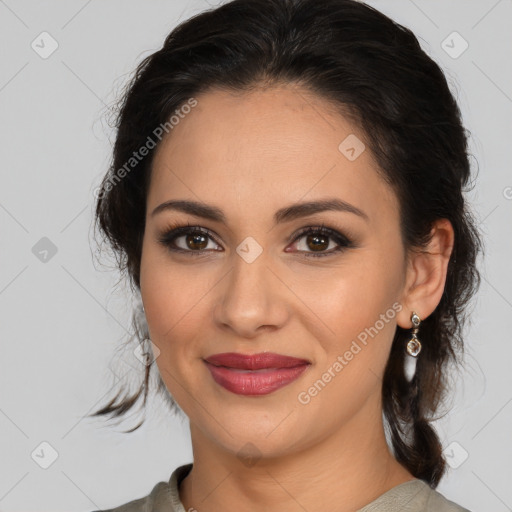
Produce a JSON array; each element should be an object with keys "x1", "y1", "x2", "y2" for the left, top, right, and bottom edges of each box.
[{"x1": 94, "y1": 463, "x2": 470, "y2": 512}]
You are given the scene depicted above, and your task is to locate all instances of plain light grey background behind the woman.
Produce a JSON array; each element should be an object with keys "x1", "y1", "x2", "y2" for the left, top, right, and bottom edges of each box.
[{"x1": 0, "y1": 0, "x2": 512, "y2": 512}]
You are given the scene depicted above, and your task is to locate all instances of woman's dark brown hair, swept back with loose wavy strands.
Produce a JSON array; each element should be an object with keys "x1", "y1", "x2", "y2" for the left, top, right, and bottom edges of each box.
[{"x1": 87, "y1": 0, "x2": 482, "y2": 487}]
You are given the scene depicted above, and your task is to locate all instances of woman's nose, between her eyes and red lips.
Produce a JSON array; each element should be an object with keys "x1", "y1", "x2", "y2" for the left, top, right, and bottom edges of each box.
[{"x1": 214, "y1": 254, "x2": 290, "y2": 339}]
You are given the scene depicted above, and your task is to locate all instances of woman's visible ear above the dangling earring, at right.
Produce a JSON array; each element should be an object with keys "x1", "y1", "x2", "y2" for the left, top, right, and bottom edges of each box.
[{"x1": 397, "y1": 219, "x2": 454, "y2": 329}]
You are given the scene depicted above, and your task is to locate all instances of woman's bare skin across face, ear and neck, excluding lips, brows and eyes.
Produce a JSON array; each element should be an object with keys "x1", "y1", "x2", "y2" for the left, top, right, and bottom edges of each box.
[{"x1": 141, "y1": 85, "x2": 453, "y2": 512}]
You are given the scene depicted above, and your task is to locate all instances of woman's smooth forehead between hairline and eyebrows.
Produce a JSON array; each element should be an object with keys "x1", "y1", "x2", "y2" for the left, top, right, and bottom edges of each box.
[{"x1": 148, "y1": 85, "x2": 396, "y2": 228}]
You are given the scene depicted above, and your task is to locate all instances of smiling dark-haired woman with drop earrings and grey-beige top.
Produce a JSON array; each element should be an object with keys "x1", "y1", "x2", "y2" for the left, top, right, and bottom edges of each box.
[{"x1": 89, "y1": 0, "x2": 481, "y2": 512}]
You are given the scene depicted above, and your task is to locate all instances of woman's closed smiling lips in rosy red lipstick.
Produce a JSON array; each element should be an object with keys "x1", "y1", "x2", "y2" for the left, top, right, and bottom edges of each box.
[{"x1": 205, "y1": 352, "x2": 311, "y2": 395}]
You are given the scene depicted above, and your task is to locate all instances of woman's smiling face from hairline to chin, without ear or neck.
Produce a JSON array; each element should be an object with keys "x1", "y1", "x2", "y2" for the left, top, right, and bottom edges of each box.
[{"x1": 141, "y1": 86, "x2": 412, "y2": 456}]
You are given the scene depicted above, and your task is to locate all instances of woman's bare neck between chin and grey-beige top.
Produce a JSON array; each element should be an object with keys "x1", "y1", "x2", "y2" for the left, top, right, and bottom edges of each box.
[{"x1": 180, "y1": 400, "x2": 414, "y2": 512}]
